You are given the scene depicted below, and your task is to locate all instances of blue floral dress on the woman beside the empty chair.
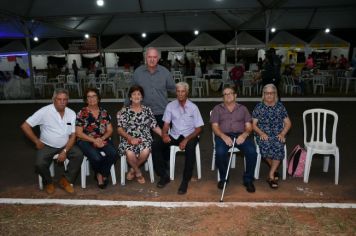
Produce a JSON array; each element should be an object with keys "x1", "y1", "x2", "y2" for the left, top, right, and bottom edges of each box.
[{"x1": 252, "y1": 102, "x2": 288, "y2": 160}]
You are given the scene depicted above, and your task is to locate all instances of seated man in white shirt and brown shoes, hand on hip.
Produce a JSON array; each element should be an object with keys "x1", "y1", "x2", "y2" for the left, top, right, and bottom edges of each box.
[{"x1": 21, "y1": 89, "x2": 83, "y2": 194}]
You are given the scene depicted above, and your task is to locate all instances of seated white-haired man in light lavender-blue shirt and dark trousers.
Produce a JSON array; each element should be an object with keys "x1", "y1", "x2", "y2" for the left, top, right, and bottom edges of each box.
[{"x1": 156, "y1": 82, "x2": 204, "y2": 194}]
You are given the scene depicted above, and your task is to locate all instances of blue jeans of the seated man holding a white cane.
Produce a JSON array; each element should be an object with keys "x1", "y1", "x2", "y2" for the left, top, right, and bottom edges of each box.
[{"x1": 215, "y1": 133, "x2": 257, "y2": 184}]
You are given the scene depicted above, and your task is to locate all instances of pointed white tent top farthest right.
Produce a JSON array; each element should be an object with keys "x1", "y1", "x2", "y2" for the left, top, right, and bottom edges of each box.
[{"x1": 309, "y1": 32, "x2": 350, "y2": 48}]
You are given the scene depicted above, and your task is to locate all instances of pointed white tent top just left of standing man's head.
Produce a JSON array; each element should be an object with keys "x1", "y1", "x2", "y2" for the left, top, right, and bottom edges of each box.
[{"x1": 104, "y1": 35, "x2": 143, "y2": 52}]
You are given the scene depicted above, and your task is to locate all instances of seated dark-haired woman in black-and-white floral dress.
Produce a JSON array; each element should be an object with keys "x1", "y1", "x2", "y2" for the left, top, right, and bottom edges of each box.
[{"x1": 117, "y1": 85, "x2": 161, "y2": 184}]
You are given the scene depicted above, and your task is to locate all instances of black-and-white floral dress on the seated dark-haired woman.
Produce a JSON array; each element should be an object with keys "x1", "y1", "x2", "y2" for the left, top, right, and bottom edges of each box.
[{"x1": 117, "y1": 105, "x2": 157, "y2": 155}]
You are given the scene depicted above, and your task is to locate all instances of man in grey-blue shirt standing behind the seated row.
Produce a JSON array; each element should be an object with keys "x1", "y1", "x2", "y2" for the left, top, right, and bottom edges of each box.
[{"x1": 132, "y1": 47, "x2": 175, "y2": 188}]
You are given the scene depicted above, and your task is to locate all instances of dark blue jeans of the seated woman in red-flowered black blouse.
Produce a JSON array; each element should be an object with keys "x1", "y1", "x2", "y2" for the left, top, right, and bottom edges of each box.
[{"x1": 77, "y1": 140, "x2": 118, "y2": 177}]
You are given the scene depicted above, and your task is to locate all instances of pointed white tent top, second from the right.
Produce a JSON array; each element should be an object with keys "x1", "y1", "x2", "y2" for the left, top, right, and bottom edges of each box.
[{"x1": 268, "y1": 31, "x2": 307, "y2": 48}]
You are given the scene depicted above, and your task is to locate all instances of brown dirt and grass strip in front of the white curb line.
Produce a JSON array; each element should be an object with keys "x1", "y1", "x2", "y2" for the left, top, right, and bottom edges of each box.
[{"x1": 0, "y1": 205, "x2": 356, "y2": 235}]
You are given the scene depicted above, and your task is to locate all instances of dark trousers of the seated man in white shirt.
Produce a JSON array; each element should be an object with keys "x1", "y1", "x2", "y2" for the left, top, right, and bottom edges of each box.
[{"x1": 35, "y1": 145, "x2": 83, "y2": 185}]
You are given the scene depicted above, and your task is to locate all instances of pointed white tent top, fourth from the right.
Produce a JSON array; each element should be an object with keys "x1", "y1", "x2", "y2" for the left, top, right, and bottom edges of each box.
[{"x1": 185, "y1": 33, "x2": 225, "y2": 50}]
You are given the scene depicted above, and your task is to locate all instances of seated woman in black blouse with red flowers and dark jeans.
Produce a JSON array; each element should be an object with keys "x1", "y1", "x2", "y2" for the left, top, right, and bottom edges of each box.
[{"x1": 75, "y1": 88, "x2": 118, "y2": 188}]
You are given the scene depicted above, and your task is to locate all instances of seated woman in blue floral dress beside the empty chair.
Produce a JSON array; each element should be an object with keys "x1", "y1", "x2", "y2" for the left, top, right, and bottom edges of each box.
[{"x1": 252, "y1": 84, "x2": 291, "y2": 189}]
